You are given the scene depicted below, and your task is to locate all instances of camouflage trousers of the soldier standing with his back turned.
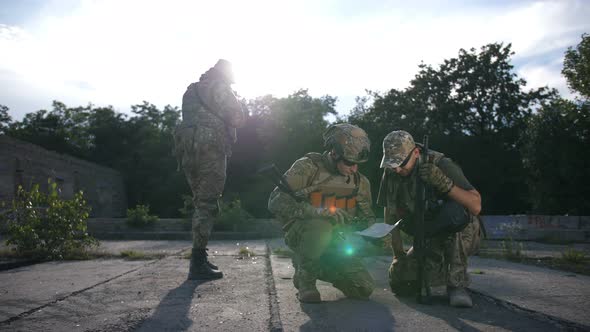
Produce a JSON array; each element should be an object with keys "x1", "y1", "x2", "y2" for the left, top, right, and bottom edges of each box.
[{"x1": 182, "y1": 144, "x2": 227, "y2": 249}]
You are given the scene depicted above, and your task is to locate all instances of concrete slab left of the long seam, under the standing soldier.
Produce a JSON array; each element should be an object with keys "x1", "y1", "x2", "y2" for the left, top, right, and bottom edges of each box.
[{"x1": 0, "y1": 243, "x2": 270, "y2": 331}]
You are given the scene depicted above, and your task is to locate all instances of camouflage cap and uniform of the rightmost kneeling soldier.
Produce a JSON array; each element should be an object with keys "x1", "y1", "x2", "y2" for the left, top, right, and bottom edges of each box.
[{"x1": 377, "y1": 132, "x2": 482, "y2": 291}]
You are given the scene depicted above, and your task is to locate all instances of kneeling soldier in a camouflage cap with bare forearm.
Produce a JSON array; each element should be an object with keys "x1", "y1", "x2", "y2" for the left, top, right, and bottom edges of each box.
[{"x1": 377, "y1": 130, "x2": 483, "y2": 307}]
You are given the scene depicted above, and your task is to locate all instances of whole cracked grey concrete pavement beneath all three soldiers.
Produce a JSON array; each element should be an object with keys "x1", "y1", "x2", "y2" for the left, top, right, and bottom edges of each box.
[{"x1": 0, "y1": 239, "x2": 590, "y2": 331}]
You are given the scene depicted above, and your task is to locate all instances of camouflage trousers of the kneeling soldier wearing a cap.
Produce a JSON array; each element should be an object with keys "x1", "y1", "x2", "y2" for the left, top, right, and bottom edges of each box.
[{"x1": 389, "y1": 216, "x2": 482, "y2": 289}]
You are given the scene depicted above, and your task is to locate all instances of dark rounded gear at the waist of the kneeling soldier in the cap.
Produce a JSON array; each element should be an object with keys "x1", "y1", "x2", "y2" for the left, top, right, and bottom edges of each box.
[{"x1": 401, "y1": 200, "x2": 471, "y2": 238}]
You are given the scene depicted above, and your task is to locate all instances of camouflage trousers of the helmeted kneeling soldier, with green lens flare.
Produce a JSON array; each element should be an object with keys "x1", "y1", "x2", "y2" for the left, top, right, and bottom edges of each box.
[{"x1": 285, "y1": 219, "x2": 375, "y2": 299}]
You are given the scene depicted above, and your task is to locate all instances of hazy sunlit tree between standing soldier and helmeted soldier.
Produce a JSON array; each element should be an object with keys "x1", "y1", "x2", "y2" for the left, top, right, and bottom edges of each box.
[{"x1": 224, "y1": 90, "x2": 336, "y2": 217}]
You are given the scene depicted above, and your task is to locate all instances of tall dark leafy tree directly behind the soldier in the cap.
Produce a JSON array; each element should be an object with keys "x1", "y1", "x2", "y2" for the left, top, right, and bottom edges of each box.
[{"x1": 349, "y1": 43, "x2": 556, "y2": 214}]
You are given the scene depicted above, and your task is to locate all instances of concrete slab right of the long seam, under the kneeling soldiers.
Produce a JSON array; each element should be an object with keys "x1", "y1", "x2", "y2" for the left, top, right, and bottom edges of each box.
[{"x1": 270, "y1": 240, "x2": 560, "y2": 331}]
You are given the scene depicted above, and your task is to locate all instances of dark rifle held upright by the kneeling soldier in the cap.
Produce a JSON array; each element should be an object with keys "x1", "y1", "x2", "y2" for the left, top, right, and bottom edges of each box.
[{"x1": 414, "y1": 135, "x2": 431, "y2": 304}]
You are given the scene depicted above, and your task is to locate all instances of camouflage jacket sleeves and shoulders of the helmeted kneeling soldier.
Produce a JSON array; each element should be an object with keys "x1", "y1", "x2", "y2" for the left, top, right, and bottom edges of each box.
[{"x1": 268, "y1": 152, "x2": 375, "y2": 223}]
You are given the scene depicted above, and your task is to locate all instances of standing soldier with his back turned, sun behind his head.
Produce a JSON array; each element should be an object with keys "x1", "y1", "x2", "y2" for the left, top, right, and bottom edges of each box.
[{"x1": 174, "y1": 59, "x2": 245, "y2": 280}]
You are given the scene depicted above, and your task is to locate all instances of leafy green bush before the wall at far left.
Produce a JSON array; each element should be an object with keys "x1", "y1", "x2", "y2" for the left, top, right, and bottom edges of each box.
[{"x1": 3, "y1": 180, "x2": 98, "y2": 260}]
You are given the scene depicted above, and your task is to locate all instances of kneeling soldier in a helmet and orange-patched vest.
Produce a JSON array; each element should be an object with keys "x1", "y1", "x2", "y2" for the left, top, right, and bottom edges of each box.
[{"x1": 268, "y1": 124, "x2": 374, "y2": 302}]
